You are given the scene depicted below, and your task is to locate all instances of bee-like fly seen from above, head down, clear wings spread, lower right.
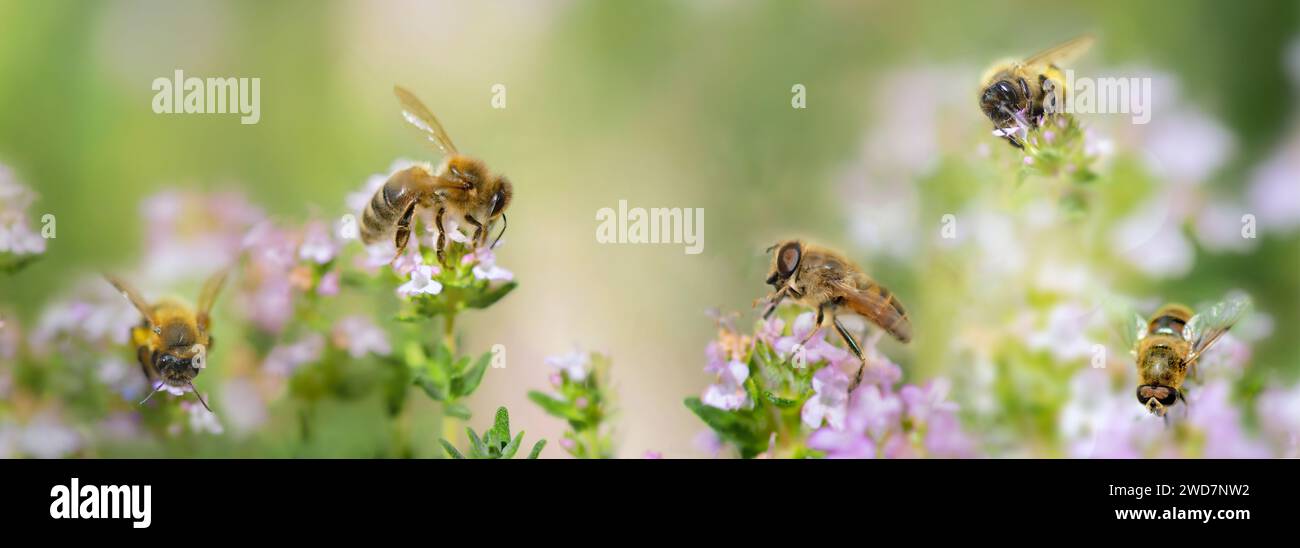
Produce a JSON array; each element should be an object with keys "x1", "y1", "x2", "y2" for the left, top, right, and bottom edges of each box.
[{"x1": 1125, "y1": 296, "x2": 1251, "y2": 417}]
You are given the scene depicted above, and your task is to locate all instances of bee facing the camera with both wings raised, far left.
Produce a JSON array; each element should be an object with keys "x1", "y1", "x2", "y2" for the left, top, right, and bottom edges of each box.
[{"x1": 104, "y1": 270, "x2": 228, "y2": 412}]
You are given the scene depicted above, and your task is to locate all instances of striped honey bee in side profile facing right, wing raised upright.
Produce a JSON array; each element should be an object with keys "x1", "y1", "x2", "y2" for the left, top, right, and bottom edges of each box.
[{"x1": 360, "y1": 86, "x2": 514, "y2": 264}]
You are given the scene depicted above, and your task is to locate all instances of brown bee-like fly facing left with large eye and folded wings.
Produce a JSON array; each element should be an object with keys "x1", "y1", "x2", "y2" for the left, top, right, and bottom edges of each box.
[{"x1": 763, "y1": 240, "x2": 911, "y2": 390}]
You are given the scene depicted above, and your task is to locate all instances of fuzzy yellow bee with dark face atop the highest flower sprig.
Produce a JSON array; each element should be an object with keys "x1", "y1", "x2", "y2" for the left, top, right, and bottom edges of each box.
[{"x1": 979, "y1": 35, "x2": 1093, "y2": 148}]
